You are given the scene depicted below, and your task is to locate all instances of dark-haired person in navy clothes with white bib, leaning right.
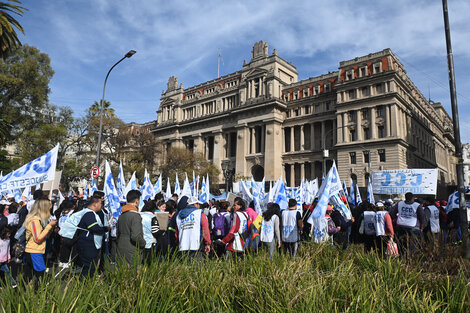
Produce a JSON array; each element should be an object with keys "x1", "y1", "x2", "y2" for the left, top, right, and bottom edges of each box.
[{"x1": 77, "y1": 196, "x2": 109, "y2": 277}]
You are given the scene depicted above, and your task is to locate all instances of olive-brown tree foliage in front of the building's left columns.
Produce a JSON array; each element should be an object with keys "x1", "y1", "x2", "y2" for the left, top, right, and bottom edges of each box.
[{"x1": 160, "y1": 148, "x2": 220, "y2": 189}]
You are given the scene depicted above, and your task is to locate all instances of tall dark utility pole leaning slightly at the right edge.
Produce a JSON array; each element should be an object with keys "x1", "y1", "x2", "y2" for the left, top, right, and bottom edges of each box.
[{"x1": 442, "y1": 0, "x2": 470, "y2": 259}]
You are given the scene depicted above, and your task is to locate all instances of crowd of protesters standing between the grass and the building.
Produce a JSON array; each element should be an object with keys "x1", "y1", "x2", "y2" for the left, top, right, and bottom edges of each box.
[{"x1": 0, "y1": 186, "x2": 461, "y2": 288}]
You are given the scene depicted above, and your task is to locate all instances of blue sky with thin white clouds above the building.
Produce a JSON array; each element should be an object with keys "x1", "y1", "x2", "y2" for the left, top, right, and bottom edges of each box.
[{"x1": 17, "y1": 0, "x2": 470, "y2": 143}]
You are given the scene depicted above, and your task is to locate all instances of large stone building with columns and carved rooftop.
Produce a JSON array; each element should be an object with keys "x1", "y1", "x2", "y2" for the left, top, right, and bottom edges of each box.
[{"x1": 152, "y1": 41, "x2": 456, "y2": 194}]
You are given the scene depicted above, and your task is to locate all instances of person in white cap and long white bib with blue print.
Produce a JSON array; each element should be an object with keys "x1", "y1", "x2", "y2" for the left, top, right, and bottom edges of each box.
[{"x1": 176, "y1": 197, "x2": 211, "y2": 257}]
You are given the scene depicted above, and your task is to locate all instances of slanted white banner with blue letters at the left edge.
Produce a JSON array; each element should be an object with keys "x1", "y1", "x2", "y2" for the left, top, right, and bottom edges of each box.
[{"x1": 0, "y1": 144, "x2": 59, "y2": 192}]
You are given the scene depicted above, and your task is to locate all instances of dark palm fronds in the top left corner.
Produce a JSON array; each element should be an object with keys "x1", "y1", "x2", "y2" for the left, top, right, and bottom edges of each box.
[{"x1": 0, "y1": 0, "x2": 26, "y2": 59}]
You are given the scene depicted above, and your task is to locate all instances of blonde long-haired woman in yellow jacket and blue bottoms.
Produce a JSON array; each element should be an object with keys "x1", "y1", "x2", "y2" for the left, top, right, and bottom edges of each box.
[{"x1": 23, "y1": 199, "x2": 57, "y2": 289}]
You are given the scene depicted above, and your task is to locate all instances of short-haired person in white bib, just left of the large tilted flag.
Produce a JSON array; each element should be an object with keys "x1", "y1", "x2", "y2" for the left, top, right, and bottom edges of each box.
[{"x1": 282, "y1": 199, "x2": 304, "y2": 257}]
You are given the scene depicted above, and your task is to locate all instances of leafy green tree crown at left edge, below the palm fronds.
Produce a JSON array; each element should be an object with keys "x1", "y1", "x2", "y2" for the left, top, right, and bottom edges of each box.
[{"x1": 0, "y1": 45, "x2": 54, "y2": 145}]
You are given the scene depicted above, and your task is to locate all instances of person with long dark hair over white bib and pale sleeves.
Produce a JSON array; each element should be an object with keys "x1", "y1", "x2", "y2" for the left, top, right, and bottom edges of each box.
[{"x1": 260, "y1": 202, "x2": 281, "y2": 259}]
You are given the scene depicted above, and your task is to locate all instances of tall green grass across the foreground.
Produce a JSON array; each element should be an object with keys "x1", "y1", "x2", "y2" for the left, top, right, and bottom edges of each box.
[{"x1": 0, "y1": 244, "x2": 470, "y2": 313}]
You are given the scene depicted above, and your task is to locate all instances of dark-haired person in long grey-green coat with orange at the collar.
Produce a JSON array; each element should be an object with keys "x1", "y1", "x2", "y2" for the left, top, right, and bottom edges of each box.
[{"x1": 116, "y1": 190, "x2": 145, "y2": 266}]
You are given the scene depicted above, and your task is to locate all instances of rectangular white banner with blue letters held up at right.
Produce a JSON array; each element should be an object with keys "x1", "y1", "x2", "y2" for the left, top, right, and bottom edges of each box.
[{"x1": 372, "y1": 168, "x2": 437, "y2": 195}]
